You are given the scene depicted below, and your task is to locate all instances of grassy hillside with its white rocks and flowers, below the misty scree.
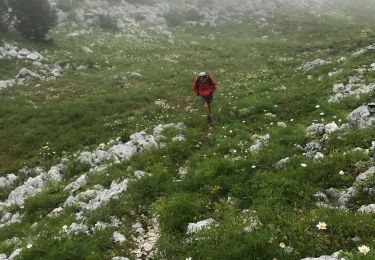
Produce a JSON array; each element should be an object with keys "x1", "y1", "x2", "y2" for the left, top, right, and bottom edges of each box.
[{"x1": 0, "y1": 6, "x2": 375, "y2": 260}]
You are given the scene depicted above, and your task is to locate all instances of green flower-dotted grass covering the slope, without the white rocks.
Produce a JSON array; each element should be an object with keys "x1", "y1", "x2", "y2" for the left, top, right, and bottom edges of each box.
[{"x1": 0, "y1": 8, "x2": 375, "y2": 259}]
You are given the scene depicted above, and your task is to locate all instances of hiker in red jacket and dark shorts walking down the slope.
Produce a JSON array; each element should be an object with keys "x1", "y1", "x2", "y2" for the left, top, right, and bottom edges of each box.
[{"x1": 193, "y1": 72, "x2": 216, "y2": 123}]
